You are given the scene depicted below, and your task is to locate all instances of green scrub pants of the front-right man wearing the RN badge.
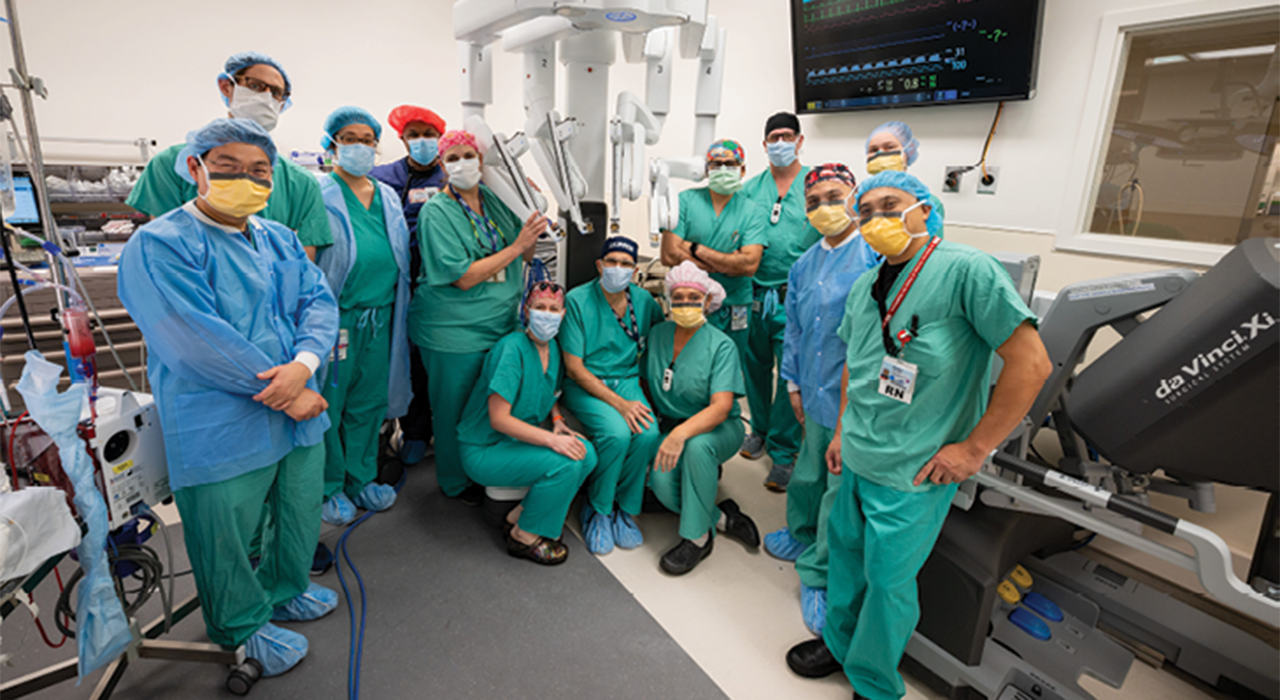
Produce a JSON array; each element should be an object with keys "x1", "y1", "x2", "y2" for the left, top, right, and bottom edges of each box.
[{"x1": 823, "y1": 470, "x2": 959, "y2": 700}]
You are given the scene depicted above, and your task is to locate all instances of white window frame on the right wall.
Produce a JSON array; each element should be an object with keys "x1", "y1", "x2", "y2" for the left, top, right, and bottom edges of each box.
[{"x1": 1055, "y1": 0, "x2": 1276, "y2": 266}]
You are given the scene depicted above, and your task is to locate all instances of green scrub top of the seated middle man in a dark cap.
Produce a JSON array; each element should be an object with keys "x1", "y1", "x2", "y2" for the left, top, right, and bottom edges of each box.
[{"x1": 556, "y1": 279, "x2": 663, "y2": 379}]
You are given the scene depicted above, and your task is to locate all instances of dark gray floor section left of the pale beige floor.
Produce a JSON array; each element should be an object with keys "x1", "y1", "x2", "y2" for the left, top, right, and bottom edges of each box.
[{"x1": 0, "y1": 466, "x2": 724, "y2": 700}]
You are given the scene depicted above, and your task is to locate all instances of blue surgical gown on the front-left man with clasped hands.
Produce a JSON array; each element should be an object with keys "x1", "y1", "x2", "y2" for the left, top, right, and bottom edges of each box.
[{"x1": 119, "y1": 207, "x2": 338, "y2": 490}]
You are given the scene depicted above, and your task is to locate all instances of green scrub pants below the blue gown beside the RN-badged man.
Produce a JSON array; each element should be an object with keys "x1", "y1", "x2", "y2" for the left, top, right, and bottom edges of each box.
[{"x1": 787, "y1": 413, "x2": 841, "y2": 589}]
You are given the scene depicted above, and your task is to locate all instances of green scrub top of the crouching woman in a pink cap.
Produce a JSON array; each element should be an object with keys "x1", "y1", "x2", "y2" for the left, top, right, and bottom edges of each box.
[{"x1": 644, "y1": 321, "x2": 746, "y2": 421}]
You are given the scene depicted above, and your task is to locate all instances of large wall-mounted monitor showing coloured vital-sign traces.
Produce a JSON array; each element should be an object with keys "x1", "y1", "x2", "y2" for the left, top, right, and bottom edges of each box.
[{"x1": 791, "y1": 0, "x2": 1044, "y2": 114}]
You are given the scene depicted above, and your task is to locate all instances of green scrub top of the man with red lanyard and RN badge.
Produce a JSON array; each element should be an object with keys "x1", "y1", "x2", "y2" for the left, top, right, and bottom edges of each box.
[{"x1": 837, "y1": 241, "x2": 1036, "y2": 491}]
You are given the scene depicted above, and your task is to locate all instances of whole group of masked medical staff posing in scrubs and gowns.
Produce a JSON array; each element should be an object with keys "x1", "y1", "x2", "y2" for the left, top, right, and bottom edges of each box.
[{"x1": 112, "y1": 52, "x2": 1048, "y2": 700}]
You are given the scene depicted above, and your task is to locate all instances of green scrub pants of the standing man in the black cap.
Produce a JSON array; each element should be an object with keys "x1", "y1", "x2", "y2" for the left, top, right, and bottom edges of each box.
[{"x1": 742, "y1": 287, "x2": 801, "y2": 468}]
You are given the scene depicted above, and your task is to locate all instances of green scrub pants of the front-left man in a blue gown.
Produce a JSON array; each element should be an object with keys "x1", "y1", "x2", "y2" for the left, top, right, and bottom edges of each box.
[{"x1": 173, "y1": 444, "x2": 324, "y2": 646}]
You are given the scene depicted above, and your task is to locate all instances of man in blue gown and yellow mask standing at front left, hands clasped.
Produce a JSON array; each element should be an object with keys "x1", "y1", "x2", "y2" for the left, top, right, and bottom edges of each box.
[{"x1": 119, "y1": 119, "x2": 338, "y2": 676}]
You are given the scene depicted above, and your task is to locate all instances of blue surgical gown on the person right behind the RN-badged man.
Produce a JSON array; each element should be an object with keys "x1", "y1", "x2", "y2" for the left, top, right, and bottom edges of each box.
[{"x1": 780, "y1": 233, "x2": 882, "y2": 430}]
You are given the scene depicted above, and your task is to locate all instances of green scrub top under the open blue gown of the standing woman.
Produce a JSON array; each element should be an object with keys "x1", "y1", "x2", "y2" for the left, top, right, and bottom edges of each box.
[{"x1": 329, "y1": 173, "x2": 399, "y2": 308}]
